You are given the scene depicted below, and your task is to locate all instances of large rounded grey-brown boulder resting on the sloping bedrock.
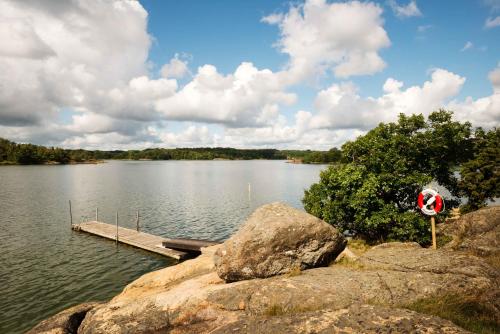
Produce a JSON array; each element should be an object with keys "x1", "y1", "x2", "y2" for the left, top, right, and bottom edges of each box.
[{"x1": 214, "y1": 203, "x2": 346, "y2": 282}]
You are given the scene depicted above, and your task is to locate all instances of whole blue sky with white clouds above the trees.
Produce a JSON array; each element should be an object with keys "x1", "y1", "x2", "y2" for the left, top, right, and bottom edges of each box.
[{"x1": 0, "y1": 0, "x2": 500, "y2": 150}]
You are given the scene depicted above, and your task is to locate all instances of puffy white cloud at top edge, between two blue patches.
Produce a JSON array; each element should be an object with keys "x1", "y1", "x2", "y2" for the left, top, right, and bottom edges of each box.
[{"x1": 262, "y1": 0, "x2": 390, "y2": 82}]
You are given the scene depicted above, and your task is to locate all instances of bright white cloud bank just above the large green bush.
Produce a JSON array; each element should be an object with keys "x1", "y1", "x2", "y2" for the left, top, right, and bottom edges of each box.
[{"x1": 307, "y1": 67, "x2": 500, "y2": 130}]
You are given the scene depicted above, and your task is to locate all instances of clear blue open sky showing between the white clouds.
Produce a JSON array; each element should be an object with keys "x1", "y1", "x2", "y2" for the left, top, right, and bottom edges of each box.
[{"x1": 141, "y1": 0, "x2": 500, "y2": 98}]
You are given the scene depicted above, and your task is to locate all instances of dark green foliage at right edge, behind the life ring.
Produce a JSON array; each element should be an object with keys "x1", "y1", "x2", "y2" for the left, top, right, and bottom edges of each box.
[{"x1": 460, "y1": 128, "x2": 500, "y2": 213}]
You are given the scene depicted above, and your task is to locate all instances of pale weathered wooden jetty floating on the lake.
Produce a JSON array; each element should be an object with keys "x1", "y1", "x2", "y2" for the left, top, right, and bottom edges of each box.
[{"x1": 71, "y1": 221, "x2": 189, "y2": 260}]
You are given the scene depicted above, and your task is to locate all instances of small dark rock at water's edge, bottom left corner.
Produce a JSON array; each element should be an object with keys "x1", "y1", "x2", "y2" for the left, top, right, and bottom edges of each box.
[{"x1": 26, "y1": 303, "x2": 99, "y2": 334}]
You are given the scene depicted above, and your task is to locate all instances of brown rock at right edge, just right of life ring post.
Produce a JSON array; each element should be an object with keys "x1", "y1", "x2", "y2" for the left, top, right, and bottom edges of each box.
[{"x1": 438, "y1": 205, "x2": 500, "y2": 256}]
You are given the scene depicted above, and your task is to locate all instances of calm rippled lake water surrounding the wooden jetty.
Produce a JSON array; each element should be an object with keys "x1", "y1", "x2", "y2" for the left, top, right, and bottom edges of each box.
[{"x1": 0, "y1": 161, "x2": 325, "y2": 333}]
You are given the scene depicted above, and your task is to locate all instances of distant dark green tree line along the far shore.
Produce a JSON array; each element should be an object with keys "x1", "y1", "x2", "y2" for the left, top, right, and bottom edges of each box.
[{"x1": 0, "y1": 138, "x2": 340, "y2": 164}]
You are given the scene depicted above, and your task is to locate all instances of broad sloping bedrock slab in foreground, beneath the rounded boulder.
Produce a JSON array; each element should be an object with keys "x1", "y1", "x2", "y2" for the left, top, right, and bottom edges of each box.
[{"x1": 31, "y1": 206, "x2": 500, "y2": 334}]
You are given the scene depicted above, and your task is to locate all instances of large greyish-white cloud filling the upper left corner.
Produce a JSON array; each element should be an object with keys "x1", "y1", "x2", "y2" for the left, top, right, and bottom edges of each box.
[{"x1": 0, "y1": 1, "x2": 151, "y2": 125}]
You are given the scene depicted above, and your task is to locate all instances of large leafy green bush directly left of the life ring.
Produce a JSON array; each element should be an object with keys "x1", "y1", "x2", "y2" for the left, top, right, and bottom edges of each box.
[{"x1": 303, "y1": 110, "x2": 472, "y2": 244}]
